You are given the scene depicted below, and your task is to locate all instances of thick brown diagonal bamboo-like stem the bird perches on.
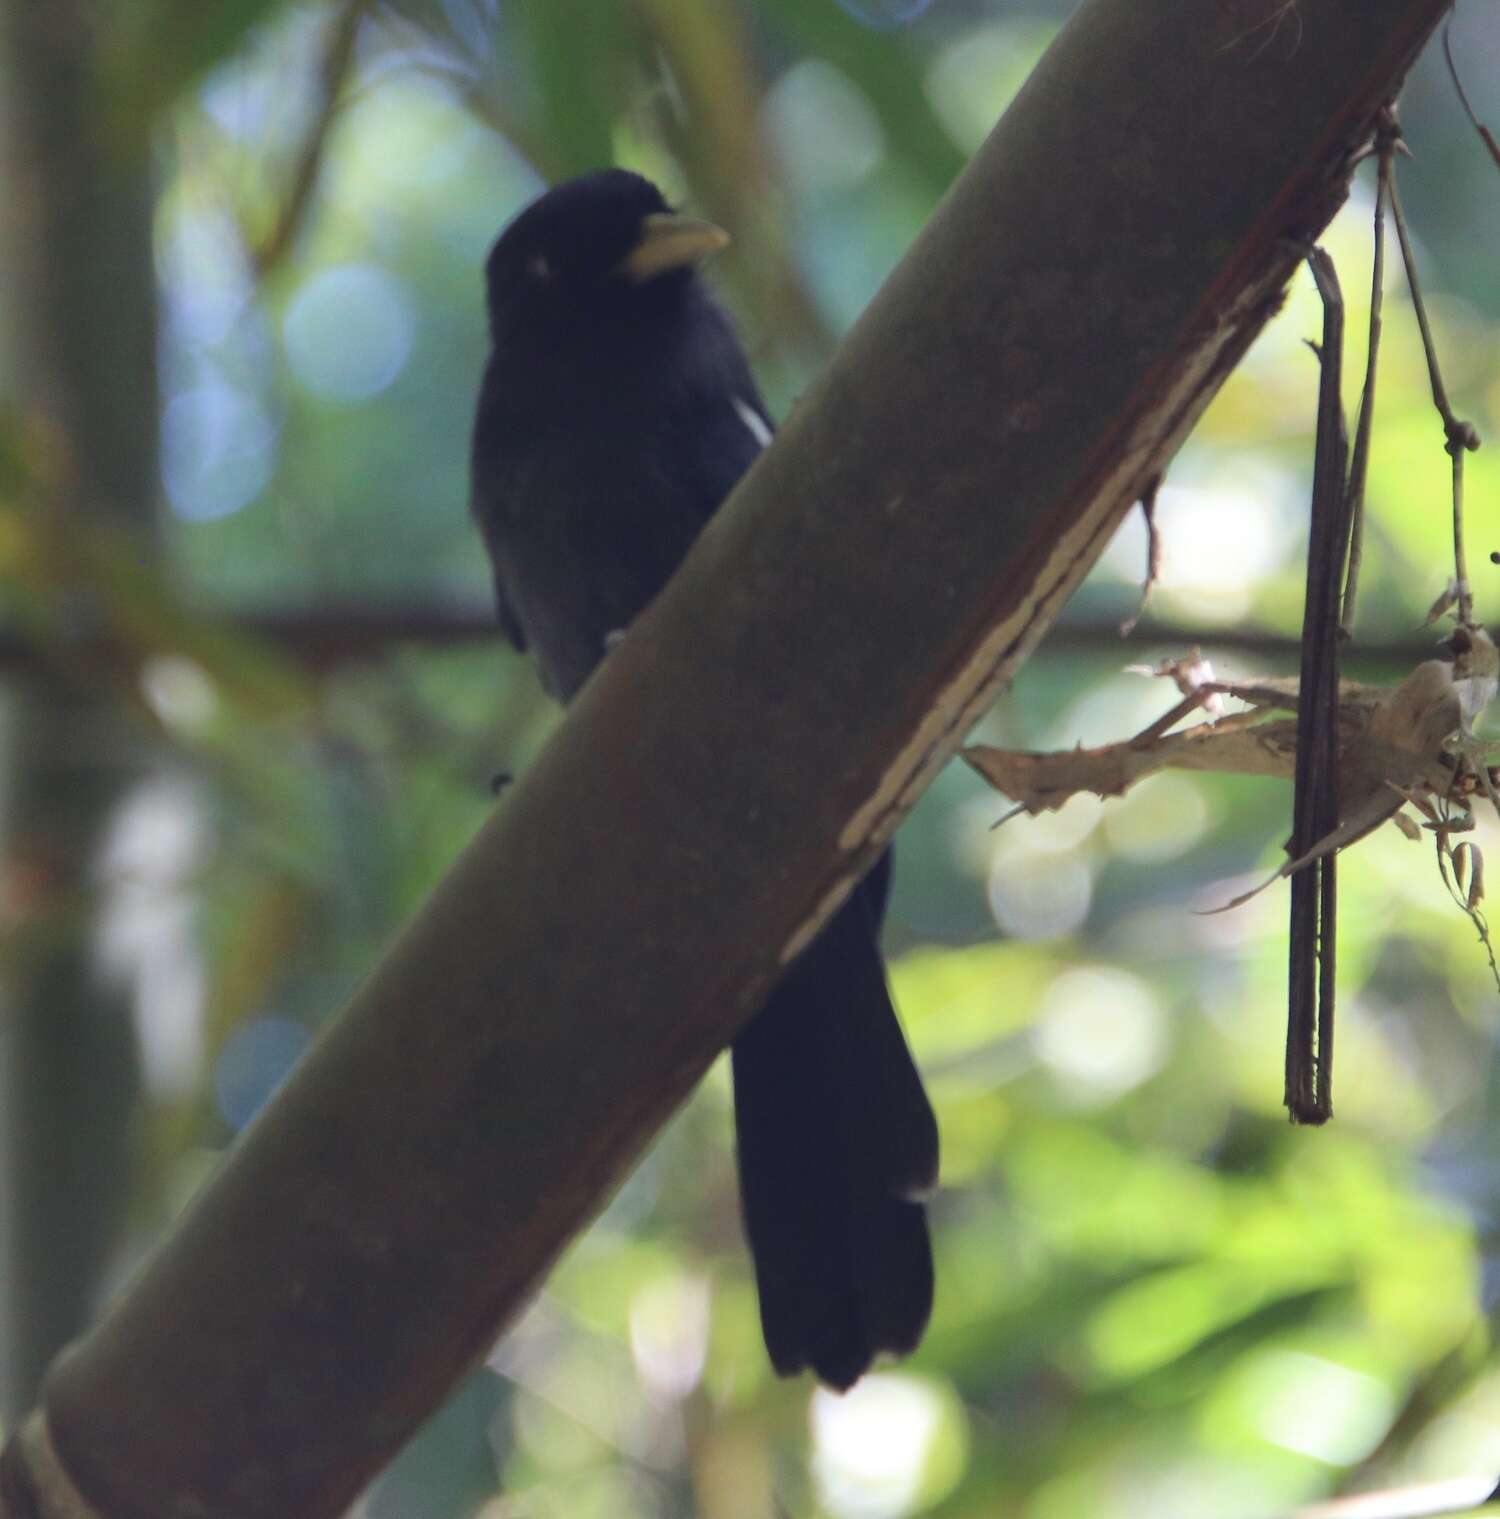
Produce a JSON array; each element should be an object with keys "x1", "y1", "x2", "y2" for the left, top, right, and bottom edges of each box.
[{"x1": 3, "y1": 0, "x2": 1447, "y2": 1519}]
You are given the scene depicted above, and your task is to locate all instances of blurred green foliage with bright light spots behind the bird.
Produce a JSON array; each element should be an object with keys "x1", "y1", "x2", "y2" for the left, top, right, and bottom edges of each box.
[{"x1": 0, "y1": 0, "x2": 1500, "y2": 1519}]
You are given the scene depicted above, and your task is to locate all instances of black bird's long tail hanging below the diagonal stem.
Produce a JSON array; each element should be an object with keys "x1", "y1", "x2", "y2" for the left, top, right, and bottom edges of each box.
[{"x1": 734, "y1": 857, "x2": 938, "y2": 1388}]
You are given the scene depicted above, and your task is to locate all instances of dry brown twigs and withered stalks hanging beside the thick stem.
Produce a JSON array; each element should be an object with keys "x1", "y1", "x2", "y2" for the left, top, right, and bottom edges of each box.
[{"x1": 965, "y1": 108, "x2": 1500, "y2": 1124}]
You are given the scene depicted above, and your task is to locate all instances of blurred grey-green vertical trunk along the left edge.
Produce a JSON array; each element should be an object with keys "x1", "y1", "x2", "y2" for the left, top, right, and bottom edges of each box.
[{"x1": 0, "y1": 0, "x2": 157, "y2": 1422}]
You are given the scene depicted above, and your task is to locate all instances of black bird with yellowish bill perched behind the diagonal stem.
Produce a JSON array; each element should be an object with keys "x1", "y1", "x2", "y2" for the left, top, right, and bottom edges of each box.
[{"x1": 473, "y1": 169, "x2": 938, "y2": 1388}]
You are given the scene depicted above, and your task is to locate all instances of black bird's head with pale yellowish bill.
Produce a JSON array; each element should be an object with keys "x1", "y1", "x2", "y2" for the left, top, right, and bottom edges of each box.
[{"x1": 485, "y1": 169, "x2": 729, "y2": 340}]
